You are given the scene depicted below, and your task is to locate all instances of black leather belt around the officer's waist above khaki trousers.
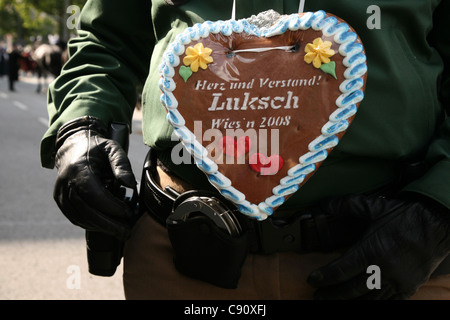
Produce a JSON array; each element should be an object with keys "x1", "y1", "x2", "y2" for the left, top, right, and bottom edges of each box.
[{"x1": 140, "y1": 151, "x2": 365, "y2": 254}]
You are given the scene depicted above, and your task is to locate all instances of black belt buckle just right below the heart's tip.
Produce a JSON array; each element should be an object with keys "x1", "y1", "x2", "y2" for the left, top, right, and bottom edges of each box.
[{"x1": 256, "y1": 214, "x2": 311, "y2": 254}]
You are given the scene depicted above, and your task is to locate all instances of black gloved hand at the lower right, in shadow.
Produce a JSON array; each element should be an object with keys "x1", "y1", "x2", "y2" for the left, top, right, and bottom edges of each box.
[{"x1": 308, "y1": 194, "x2": 450, "y2": 299}]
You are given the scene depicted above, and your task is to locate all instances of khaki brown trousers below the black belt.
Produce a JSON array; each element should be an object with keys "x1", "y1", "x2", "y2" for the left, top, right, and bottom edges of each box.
[{"x1": 123, "y1": 214, "x2": 450, "y2": 300}]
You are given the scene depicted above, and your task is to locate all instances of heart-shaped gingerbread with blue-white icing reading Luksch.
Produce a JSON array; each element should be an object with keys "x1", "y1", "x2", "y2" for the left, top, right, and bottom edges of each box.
[{"x1": 159, "y1": 11, "x2": 367, "y2": 220}]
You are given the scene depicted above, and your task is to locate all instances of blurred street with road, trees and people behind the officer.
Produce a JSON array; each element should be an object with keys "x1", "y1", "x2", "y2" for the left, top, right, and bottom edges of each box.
[{"x1": 0, "y1": 0, "x2": 147, "y2": 300}]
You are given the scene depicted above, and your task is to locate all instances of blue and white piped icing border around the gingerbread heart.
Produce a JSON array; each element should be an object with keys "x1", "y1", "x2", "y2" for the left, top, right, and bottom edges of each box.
[{"x1": 158, "y1": 10, "x2": 367, "y2": 220}]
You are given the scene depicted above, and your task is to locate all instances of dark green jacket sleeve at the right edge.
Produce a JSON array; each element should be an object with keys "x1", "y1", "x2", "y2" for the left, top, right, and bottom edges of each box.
[{"x1": 406, "y1": 0, "x2": 450, "y2": 208}]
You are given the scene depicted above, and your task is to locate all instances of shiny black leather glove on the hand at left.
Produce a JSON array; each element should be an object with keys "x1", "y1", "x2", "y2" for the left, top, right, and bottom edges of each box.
[{"x1": 53, "y1": 116, "x2": 136, "y2": 241}]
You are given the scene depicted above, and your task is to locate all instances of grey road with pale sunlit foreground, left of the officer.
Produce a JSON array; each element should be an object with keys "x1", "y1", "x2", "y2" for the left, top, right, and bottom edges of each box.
[{"x1": 0, "y1": 76, "x2": 146, "y2": 300}]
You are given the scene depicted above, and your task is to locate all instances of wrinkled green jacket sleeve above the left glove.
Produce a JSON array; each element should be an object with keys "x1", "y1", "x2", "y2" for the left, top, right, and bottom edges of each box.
[{"x1": 40, "y1": 0, "x2": 155, "y2": 168}]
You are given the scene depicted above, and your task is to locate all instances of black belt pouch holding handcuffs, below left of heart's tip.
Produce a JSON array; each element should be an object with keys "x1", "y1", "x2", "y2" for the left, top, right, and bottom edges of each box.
[{"x1": 167, "y1": 215, "x2": 248, "y2": 289}]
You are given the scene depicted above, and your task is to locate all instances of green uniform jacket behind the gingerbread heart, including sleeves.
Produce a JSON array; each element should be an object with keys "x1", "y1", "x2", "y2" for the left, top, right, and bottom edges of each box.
[{"x1": 41, "y1": 0, "x2": 450, "y2": 212}]
